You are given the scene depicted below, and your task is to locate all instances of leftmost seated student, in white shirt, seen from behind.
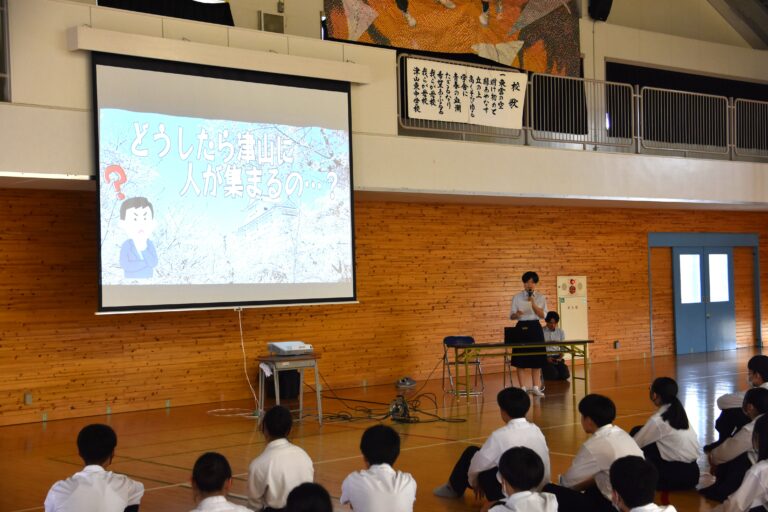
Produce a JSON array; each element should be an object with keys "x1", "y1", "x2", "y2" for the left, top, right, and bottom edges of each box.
[{"x1": 45, "y1": 424, "x2": 144, "y2": 512}]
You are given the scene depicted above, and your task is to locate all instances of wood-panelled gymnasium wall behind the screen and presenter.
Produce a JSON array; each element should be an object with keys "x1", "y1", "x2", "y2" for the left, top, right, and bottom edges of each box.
[{"x1": 0, "y1": 189, "x2": 768, "y2": 425}]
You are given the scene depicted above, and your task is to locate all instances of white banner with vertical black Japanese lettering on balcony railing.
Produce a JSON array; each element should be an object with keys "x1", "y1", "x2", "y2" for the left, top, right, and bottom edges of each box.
[{"x1": 405, "y1": 58, "x2": 528, "y2": 130}]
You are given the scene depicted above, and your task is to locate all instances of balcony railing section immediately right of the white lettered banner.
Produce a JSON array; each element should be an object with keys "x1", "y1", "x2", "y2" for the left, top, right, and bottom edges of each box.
[{"x1": 528, "y1": 74, "x2": 635, "y2": 147}]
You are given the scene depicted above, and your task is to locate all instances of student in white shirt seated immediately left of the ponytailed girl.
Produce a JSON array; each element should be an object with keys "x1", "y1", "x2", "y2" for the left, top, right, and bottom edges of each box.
[{"x1": 543, "y1": 394, "x2": 643, "y2": 512}]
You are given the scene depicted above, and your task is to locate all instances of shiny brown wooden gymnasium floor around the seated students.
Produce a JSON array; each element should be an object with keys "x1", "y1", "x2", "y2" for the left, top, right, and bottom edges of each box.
[{"x1": 0, "y1": 349, "x2": 756, "y2": 512}]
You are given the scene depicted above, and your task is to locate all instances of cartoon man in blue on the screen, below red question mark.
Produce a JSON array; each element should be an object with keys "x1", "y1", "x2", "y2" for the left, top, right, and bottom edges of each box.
[{"x1": 120, "y1": 197, "x2": 157, "y2": 278}]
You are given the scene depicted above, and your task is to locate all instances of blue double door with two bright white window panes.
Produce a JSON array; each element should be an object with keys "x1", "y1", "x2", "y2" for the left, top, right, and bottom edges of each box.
[{"x1": 672, "y1": 247, "x2": 736, "y2": 354}]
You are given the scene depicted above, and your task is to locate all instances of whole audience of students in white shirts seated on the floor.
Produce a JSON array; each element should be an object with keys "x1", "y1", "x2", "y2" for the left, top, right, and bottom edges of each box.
[{"x1": 45, "y1": 355, "x2": 768, "y2": 512}]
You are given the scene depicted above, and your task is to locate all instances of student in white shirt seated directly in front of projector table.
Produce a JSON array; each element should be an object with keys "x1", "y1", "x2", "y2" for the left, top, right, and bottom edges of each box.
[{"x1": 248, "y1": 405, "x2": 315, "y2": 511}]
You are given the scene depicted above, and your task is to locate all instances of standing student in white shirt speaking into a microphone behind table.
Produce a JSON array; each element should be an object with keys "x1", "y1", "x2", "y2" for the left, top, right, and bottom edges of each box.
[{"x1": 509, "y1": 271, "x2": 547, "y2": 396}]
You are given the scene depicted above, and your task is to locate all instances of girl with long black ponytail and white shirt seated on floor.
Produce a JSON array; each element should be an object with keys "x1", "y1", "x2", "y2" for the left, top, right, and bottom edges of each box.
[{"x1": 631, "y1": 377, "x2": 699, "y2": 491}]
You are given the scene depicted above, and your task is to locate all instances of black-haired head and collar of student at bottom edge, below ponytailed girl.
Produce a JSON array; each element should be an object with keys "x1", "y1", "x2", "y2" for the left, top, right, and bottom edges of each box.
[{"x1": 610, "y1": 455, "x2": 675, "y2": 512}]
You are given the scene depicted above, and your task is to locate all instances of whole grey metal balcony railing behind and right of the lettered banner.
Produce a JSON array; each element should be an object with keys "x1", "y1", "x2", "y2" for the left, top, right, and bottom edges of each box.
[{"x1": 398, "y1": 55, "x2": 768, "y2": 159}]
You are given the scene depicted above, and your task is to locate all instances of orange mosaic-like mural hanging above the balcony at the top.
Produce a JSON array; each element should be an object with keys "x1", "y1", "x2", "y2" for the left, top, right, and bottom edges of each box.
[{"x1": 324, "y1": 0, "x2": 580, "y2": 76}]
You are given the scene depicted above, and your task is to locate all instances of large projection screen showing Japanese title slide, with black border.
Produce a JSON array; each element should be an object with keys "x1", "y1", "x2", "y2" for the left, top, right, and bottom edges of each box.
[{"x1": 93, "y1": 53, "x2": 355, "y2": 312}]
